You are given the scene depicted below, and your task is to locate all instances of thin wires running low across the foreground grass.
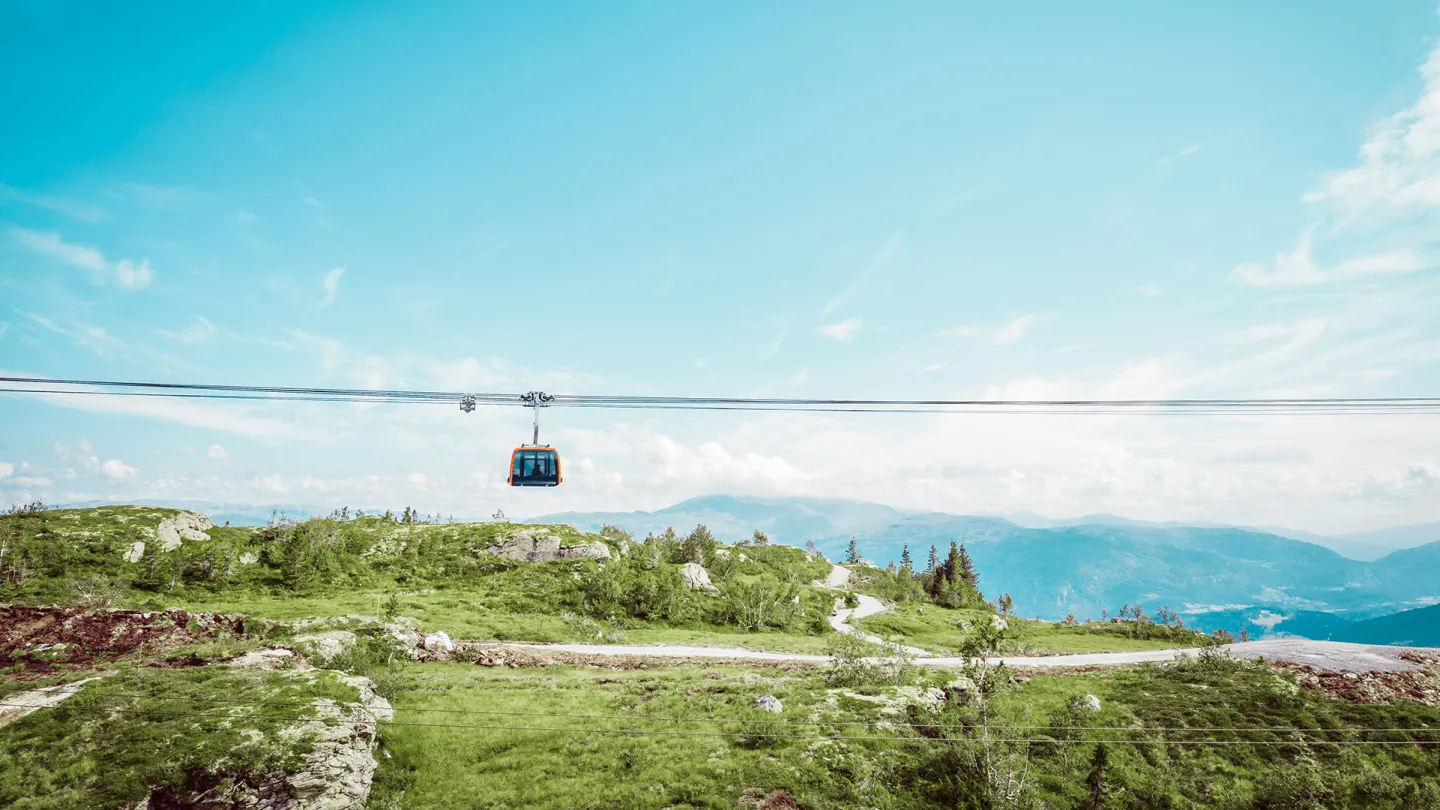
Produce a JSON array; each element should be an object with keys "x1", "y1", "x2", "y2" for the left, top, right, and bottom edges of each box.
[{"x1": 0, "y1": 703, "x2": 1440, "y2": 747}]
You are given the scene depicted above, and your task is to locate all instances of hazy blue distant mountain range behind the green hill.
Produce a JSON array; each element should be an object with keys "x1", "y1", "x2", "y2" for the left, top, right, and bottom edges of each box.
[{"x1": 530, "y1": 496, "x2": 1440, "y2": 630}]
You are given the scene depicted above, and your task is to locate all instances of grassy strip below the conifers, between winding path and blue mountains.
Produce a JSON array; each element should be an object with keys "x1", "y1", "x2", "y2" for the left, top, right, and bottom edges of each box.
[{"x1": 858, "y1": 602, "x2": 1207, "y2": 656}]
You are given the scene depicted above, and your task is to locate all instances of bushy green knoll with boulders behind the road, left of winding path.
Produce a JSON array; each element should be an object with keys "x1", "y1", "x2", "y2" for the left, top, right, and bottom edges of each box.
[{"x1": 0, "y1": 506, "x2": 831, "y2": 650}]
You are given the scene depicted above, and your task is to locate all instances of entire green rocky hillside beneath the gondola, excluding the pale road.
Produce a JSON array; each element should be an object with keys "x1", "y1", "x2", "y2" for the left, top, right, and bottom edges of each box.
[{"x1": 0, "y1": 506, "x2": 1440, "y2": 810}]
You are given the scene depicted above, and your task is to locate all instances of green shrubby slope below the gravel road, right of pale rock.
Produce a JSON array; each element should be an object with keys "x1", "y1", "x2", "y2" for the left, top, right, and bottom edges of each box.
[{"x1": 362, "y1": 634, "x2": 1440, "y2": 810}]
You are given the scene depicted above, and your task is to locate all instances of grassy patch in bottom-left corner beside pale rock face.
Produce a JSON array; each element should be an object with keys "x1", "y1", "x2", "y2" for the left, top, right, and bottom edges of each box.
[{"x1": 0, "y1": 666, "x2": 359, "y2": 810}]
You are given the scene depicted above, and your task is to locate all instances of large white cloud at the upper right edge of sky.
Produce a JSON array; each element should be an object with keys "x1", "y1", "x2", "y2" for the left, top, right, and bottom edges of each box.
[{"x1": 1303, "y1": 48, "x2": 1440, "y2": 221}]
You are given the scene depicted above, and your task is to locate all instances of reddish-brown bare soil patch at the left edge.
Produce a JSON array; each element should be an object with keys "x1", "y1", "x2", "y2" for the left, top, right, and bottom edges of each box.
[{"x1": 0, "y1": 605, "x2": 245, "y2": 670}]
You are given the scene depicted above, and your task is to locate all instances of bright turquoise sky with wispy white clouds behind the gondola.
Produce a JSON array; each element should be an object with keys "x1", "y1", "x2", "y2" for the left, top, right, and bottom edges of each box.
[{"x1": 0, "y1": 0, "x2": 1440, "y2": 533}]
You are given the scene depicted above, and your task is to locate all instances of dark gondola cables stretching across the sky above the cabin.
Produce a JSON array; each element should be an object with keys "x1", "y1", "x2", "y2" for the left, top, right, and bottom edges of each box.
[{"x1": 0, "y1": 376, "x2": 1440, "y2": 415}]
